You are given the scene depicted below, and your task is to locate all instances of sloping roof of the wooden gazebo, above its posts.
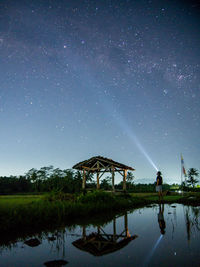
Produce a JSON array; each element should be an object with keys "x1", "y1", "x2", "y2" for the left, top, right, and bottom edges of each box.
[{"x1": 72, "y1": 156, "x2": 135, "y2": 171}]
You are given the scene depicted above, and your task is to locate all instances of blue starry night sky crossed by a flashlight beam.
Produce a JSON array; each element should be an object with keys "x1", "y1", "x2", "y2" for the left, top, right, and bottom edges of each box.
[{"x1": 0, "y1": 0, "x2": 200, "y2": 183}]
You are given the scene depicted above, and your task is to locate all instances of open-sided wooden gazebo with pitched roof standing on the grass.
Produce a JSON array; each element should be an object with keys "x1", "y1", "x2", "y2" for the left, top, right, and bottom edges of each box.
[{"x1": 73, "y1": 156, "x2": 135, "y2": 191}]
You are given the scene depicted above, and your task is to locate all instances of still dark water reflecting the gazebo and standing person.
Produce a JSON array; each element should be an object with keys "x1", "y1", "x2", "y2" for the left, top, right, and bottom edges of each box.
[{"x1": 0, "y1": 204, "x2": 200, "y2": 267}]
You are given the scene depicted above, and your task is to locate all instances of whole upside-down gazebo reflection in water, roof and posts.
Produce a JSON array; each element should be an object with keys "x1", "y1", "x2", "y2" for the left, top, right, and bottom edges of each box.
[{"x1": 72, "y1": 213, "x2": 137, "y2": 256}]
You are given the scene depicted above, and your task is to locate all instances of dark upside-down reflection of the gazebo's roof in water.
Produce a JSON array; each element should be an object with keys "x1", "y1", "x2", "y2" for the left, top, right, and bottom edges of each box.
[{"x1": 72, "y1": 233, "x2": 137, "y2": 256}]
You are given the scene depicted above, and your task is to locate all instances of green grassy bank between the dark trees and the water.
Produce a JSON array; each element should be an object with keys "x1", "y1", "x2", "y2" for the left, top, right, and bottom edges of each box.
[{"x1": 0, "y1": 191, "x2": 200, "y2": 243}]
